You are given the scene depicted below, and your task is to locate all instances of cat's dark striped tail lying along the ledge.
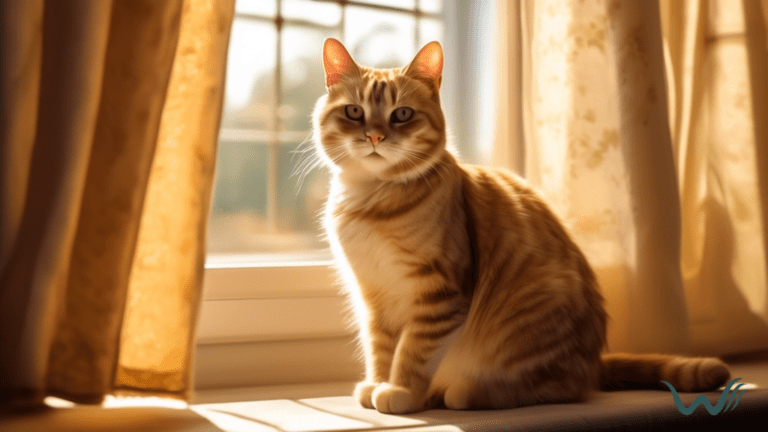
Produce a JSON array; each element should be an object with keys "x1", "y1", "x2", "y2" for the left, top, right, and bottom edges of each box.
[{"x1": 600, "y1": 354, "x2": 731, "y2": 392}]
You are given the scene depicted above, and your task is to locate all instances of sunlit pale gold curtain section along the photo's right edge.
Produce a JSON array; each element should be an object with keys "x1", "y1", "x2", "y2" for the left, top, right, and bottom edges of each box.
[{"x1": 668, "y1": 0, "x2": 768, "y2": 353}]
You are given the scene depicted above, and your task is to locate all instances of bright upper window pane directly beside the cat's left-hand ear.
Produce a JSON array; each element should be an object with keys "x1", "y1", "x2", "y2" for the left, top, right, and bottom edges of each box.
[{"x1": 278, "y1": 26, "x2": 339, "y2": 131}]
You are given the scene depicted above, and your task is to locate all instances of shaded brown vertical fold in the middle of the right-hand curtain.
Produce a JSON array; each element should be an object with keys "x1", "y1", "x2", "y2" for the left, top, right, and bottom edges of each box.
[{"x1": 608, "y1": 0, "x2": 690, "y2": 352}]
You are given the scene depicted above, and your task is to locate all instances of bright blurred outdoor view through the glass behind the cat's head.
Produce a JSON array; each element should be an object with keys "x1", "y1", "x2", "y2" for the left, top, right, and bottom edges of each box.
[{"x1": 208, "y1": 0, "x2": 443, "y2": 261}]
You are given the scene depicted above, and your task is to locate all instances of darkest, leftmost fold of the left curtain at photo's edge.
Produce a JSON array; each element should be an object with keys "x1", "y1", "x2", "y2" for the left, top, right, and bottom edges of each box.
[{"x1": 0, "y1": 0, "x2": 112, "y2": 404}]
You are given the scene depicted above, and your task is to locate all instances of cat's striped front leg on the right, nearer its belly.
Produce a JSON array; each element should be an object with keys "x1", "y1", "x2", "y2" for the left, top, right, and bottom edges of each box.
[{"x1": 372, "y1": 300, "x2": 461, "y2": 414}]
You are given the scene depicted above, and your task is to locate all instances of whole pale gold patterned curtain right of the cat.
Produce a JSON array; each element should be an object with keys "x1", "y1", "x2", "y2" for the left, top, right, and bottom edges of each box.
[{"x1": 496, "y1": 0, "x2": 768, "y2": 355}]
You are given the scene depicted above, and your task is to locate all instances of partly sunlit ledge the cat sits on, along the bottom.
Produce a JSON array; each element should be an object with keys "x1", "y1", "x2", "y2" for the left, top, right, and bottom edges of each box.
[{"x1": 0, "y1": 353, "x2": 768, "y2": 432}]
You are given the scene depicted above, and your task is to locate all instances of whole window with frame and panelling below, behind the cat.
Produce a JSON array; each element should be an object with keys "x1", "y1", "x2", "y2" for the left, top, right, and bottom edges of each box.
[{"x1": 196, "y1": 0, "x2": 488, "y2": 388}]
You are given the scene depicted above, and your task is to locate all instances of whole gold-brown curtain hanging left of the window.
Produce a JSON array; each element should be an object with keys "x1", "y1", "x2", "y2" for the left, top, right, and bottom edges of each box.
[{"x1": 0, "y1": 0, "x2": 234, "y2": 403}]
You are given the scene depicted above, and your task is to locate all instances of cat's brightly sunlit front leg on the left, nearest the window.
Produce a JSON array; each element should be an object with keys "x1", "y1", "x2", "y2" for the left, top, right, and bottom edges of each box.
[{"x1": 353, "y1": 319, "x2": 397, "y2": 408}]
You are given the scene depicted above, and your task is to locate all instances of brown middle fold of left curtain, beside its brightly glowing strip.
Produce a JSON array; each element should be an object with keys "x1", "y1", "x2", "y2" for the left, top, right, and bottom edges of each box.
[{"x1": 48, "y1": 0, "x2": 182, "y2": 402}]
